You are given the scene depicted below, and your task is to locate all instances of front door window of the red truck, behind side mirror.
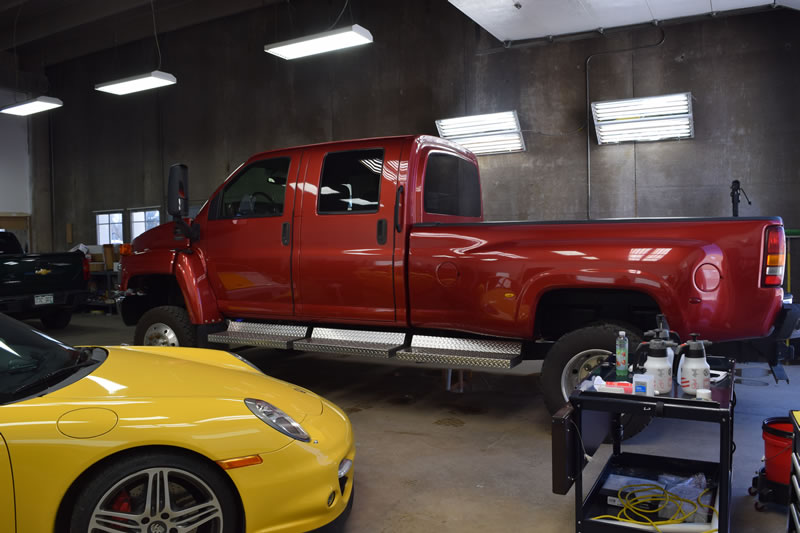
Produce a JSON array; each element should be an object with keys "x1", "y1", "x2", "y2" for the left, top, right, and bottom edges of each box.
[{"x1": 216, "y1": 157, "x2": 290, "y2": 218}]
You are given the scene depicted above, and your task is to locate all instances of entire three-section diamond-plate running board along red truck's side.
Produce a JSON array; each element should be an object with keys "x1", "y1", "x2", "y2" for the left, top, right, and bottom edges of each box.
[{"x1": 208, "y1": 321, "x2": 522, "y2": 369}]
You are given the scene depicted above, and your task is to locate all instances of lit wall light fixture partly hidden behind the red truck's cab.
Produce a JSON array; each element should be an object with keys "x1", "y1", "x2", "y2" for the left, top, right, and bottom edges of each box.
[{"x1": 436, "y1": 111, "x2": 525, "y2": 155}]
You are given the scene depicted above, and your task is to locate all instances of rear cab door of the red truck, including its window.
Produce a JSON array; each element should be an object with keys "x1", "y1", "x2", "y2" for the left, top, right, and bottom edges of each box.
[{"x1": 296, "y1": 140, "x2": 402, "y2": 323}]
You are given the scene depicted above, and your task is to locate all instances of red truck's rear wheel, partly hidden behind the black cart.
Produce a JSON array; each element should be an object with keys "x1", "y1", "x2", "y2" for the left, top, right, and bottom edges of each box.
[{"x1": 541, "y1": 323, "x2": 652, "y2": 439}]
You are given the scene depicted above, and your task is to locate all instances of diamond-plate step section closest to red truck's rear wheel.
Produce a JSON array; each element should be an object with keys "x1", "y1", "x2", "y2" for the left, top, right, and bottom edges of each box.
[{"x1": 395, "y1": 335, "x2": 522, "y2": 369}]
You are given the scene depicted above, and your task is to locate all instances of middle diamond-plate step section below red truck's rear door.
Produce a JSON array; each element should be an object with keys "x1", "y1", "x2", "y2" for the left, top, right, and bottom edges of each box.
[{"x1": 294, "y1": 328, "x2": 406, "y2": 359}]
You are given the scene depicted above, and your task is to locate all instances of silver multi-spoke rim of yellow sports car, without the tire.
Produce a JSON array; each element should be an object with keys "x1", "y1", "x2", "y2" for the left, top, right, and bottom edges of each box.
[{"x1": 88, "y1": 467, "x2": 223, "y2": 533}]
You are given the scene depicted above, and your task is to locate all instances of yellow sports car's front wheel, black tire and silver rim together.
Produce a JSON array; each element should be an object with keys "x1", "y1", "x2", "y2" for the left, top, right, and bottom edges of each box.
[{"x1": 69, "y1": 452, "x2": 240, "y2": 533}]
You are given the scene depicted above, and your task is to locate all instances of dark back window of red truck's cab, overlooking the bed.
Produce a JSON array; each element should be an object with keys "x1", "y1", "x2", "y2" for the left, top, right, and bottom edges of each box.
[{"x1": 424, "y1": 152, "x2": 481, "y2": 217}]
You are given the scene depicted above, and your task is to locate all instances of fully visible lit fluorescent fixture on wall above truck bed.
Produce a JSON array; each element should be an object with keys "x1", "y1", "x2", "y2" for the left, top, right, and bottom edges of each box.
[{"x1": 592, "y1": 93, "x2": 694, "y2": 144}]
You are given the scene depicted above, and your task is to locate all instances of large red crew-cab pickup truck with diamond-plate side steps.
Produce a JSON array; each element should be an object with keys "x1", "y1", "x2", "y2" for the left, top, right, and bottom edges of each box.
[{"x1": 120, "y1": 136, "x2": 800, "y2": 416}]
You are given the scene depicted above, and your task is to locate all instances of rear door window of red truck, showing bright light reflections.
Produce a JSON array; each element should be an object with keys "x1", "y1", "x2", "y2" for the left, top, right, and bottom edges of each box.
[{"x1": 317, "y1": 148, "x2": 383, "y2": 215}]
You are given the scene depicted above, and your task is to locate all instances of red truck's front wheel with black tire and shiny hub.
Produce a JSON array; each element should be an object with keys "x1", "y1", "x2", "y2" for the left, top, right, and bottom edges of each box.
[{"x1": 133, "y1": 305, "x2": 197, "y2": 346}]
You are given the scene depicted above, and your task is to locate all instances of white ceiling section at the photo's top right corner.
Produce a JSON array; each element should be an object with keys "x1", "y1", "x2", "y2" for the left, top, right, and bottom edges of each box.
[{"x1": 449, "y1": 0, "x2": 800, "y2": 42}]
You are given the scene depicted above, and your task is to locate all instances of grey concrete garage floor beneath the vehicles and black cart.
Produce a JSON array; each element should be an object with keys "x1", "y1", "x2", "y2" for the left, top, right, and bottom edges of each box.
[{"x1": 48, "y1": 315, "x2": 800, "y2": 533}]
